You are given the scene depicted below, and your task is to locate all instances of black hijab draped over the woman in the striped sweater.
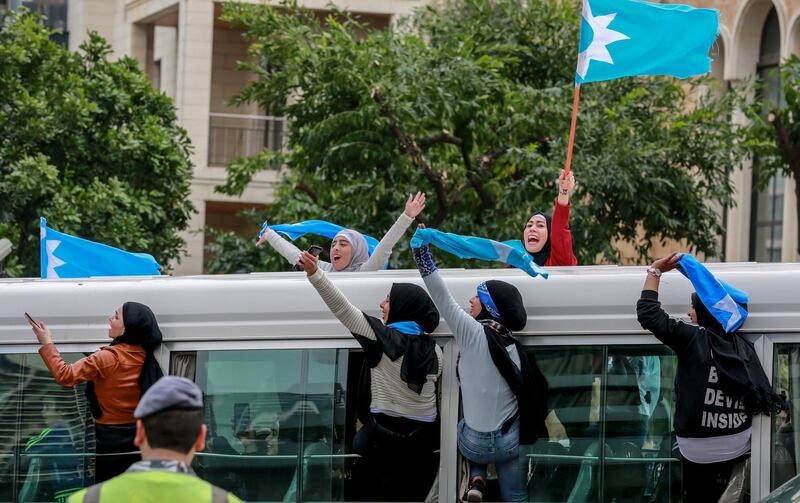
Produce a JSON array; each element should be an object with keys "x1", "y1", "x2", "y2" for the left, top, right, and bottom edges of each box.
[{"x1": 364, "y1": 283, "x2": 439, "y2": 394}]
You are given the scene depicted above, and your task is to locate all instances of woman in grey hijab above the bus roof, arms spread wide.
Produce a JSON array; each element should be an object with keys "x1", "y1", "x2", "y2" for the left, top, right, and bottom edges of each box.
[{"x1": 256, "y1": 192, "x2": 425, "y2": 272}]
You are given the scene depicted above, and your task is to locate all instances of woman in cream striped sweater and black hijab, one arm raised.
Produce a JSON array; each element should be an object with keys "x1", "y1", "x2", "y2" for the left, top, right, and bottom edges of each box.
[{"x1": 298, "y1": 252, "x2": 442, "y2": 501}]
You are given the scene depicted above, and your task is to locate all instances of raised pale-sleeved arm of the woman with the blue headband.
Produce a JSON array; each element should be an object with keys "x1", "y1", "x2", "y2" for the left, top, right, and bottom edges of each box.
[{"x1": 412, "y1": 245, "x2": 484, "y2": 350}]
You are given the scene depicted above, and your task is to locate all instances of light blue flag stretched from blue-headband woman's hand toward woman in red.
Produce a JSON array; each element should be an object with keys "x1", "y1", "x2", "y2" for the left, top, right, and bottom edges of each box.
[{"x1": 411, "y1": 229, "x2": 547, "y2": 279}]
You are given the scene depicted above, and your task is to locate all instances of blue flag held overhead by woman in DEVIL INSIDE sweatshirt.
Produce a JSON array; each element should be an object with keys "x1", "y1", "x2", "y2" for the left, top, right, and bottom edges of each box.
[{"x1": 678, "y1": 253, "x2": 750, "y2": 332}]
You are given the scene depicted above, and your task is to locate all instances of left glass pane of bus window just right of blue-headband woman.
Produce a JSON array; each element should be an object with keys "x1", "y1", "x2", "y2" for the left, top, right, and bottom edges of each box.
[{"x1": 527, "y1": 346, "x2": 603, "y2": 502}]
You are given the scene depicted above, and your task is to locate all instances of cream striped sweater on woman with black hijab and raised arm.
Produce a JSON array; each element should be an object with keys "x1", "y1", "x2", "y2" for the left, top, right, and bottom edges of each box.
[{"x1": 308, "y1": 269, "x2": 442, "y2": 422}]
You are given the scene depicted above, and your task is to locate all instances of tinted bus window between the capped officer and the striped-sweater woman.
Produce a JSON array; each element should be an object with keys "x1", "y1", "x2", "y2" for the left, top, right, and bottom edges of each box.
[{"x1": 195, "y1": 349, "x2": 348, "y2": 501}]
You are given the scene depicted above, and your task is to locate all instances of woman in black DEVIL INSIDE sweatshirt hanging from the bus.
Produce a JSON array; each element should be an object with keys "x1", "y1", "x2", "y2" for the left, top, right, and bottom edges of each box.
[{"x1": 636, "y1": 253, "x2": 782, "y2": 503}]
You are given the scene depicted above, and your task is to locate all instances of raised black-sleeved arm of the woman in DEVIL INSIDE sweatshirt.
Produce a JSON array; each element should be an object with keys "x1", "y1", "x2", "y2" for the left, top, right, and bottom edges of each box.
[{"x1": 636, "y1": 253, "x2": 697, "y2": 354}]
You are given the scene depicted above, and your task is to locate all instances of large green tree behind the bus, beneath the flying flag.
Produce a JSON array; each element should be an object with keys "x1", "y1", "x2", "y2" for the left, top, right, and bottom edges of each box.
[{"x1": 209, "y1": 0, "x2": 747, "y2": 276}]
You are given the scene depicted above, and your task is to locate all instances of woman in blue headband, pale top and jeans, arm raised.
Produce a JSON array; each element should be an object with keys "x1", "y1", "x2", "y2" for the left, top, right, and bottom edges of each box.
[{"x1": 413, "y1": 245, "x2": 547, "y2": 501}]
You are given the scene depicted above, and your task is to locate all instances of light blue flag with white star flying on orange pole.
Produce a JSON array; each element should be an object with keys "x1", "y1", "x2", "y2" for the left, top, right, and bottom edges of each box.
[{"x1": 575, "y1": 0, "x2": 719, "y2": 84}]
